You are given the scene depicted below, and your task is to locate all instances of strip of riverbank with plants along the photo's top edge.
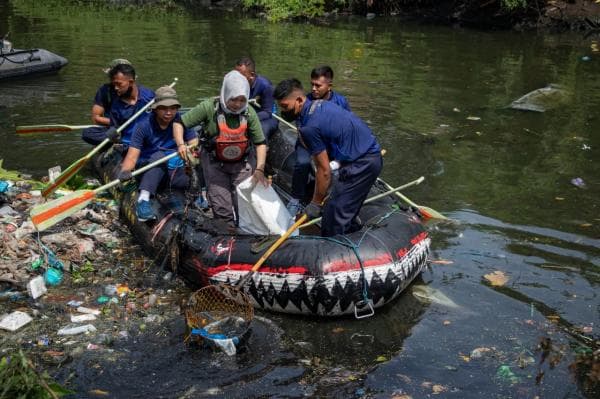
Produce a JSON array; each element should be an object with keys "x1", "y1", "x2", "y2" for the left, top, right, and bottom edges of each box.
[{"x1": 15, "y1": 0, "x2": 600, "y2": 32}]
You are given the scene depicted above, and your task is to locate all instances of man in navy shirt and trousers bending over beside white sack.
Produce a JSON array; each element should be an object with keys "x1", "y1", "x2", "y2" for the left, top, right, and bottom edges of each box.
[{"x1": 273, "y1": 79, "x2": 383, "y2": 237}]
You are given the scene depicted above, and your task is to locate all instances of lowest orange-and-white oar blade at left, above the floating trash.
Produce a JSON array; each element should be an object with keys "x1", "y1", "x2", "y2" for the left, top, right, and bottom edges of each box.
[{"x1": 29, "y1": 190, "x2": 96, "y2": 231}]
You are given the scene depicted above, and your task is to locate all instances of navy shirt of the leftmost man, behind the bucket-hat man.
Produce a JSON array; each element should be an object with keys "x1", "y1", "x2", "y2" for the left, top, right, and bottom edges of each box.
[{"x1": 94, "y1": 83, "x2": 154, "y2": 144}]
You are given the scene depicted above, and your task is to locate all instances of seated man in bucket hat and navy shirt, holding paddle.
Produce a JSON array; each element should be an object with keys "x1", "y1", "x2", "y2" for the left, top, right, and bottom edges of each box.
[{"x1": 118, "y1": 86, "x2": 198, "y2": 222}]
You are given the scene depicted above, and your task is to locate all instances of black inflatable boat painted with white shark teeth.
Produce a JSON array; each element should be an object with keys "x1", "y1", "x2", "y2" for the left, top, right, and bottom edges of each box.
[{"x1": 94, "y1": 123, "x2": 430, "y2": 317}]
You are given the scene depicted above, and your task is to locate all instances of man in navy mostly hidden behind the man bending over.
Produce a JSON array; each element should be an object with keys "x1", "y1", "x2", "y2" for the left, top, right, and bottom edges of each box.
[{"x1": 288, "y1": 65, "x2": 350, "y2": 214}]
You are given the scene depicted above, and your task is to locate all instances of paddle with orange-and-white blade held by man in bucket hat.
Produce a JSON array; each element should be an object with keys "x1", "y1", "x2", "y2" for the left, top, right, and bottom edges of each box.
[{"x1": 30, "y1": 152, "x2": 177, "y2": 231}]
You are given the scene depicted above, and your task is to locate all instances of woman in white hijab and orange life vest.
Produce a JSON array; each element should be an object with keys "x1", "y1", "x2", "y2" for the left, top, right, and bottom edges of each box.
[{"x1": 175, "y1": 71, "x2": 268, "y2": 228}]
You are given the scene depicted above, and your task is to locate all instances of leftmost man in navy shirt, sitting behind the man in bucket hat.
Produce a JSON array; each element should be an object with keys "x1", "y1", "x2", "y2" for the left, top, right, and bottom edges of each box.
[{"x1": 81, "y1": 58, "x2": 154, "y2": 150}]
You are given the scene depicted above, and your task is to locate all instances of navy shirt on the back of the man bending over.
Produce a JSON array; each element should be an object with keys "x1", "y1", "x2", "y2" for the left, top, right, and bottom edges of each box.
[{"x1": 298, "y1": 99, "x2": 381, "y2": 163}]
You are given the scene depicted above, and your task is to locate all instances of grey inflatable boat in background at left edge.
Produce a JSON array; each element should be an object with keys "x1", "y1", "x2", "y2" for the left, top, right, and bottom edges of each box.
[{"x1": 0, "y1": 40, "x2": 68, "y2": 79}]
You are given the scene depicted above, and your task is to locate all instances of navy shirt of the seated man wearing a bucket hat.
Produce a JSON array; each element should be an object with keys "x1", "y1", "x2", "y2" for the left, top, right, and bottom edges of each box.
[{"x1": 129, "y1": 113, "x2": 196, "y2": 159}]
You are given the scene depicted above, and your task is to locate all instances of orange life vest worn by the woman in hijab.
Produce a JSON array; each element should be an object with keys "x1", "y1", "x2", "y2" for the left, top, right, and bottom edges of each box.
[{"x1": 214, "y1": 112, "x2": 250, "y2": 162}]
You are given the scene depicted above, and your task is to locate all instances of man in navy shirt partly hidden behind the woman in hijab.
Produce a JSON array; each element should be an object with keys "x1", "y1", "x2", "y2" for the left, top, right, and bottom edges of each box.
[{"x1": 235, "y1": 57, "x2": 278, "y2": 142}]
